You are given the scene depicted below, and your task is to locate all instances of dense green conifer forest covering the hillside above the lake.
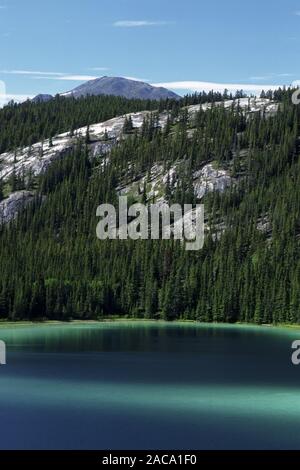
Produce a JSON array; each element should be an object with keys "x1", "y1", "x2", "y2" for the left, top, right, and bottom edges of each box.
[{"x1": 0, "y1": 91, "x2": 300, "y2": 323}]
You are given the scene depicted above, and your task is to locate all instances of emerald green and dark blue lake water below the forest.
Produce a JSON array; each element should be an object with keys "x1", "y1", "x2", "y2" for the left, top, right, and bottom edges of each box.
[{"x1": 0, "y1": 322, "x2": 300, "y2": 449}]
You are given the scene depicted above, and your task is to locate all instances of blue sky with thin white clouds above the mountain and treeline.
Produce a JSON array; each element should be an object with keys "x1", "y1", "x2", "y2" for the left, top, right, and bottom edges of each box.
[{"x1": 0, "y1": 0, "x2": 300, "y2": 98}]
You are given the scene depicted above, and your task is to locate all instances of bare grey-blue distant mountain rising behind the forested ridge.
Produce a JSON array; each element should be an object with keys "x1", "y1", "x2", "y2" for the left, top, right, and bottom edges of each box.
[{"x1": 33, "y1": 77, "x2": 180, "y2": 102}]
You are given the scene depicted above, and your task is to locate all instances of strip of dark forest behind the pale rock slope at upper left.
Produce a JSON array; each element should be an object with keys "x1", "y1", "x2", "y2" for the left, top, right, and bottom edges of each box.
[{"x1": 0, "y1": 95, "x2": 166, "y2": 153}]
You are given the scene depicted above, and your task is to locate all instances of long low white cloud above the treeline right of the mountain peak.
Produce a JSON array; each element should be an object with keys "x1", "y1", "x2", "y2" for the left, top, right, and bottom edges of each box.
[{"x1": 152, "y1": 80, "x2": 279, "y2": 94}]
